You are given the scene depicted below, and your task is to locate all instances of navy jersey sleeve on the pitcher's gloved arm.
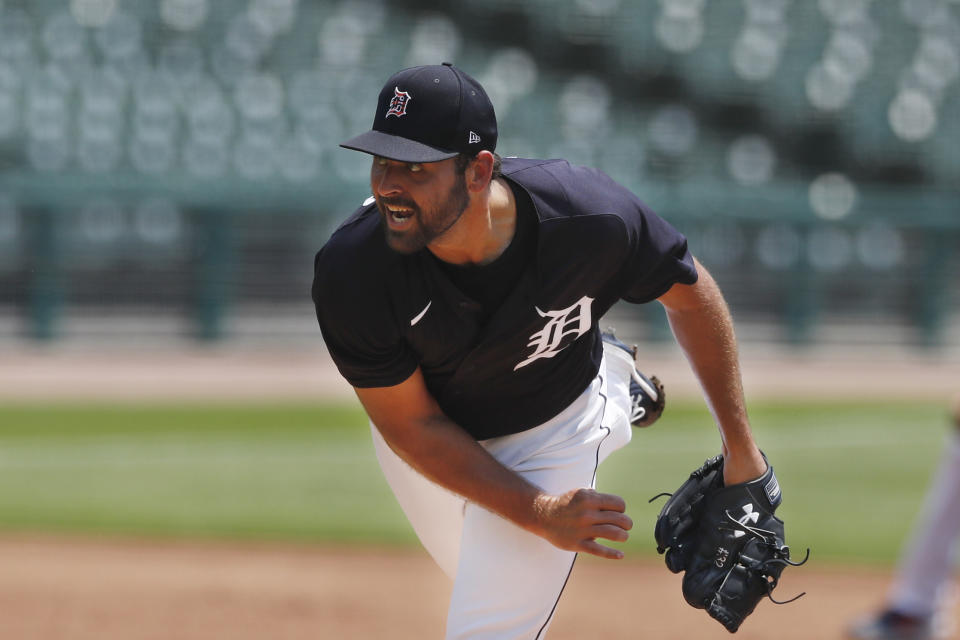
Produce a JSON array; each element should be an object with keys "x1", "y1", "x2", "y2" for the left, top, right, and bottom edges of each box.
[{"x1": 621, "y1": 202, "x2": 697, "y2": 303}]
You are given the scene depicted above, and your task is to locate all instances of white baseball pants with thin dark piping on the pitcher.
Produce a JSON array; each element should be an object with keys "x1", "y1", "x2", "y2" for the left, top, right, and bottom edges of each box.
[{"x1": 371, "y1": 344, "x2": 633, "y2": 640}]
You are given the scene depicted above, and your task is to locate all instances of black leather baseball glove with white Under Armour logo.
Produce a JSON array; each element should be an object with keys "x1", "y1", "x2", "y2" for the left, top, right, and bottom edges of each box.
[{"x1": 654, "y1": 456, "x2": 810, "y2": 633}]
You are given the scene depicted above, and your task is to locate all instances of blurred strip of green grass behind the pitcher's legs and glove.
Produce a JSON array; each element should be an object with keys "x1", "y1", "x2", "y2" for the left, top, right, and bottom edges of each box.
[{"x1": 0, "y1": 402, "x2": 947, "y2": 564}]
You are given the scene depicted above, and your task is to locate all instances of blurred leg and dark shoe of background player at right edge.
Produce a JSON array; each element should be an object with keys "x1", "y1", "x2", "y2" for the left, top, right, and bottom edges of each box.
[{"x1": 849, "y1": 395, "x2": 960, "y2": 640}]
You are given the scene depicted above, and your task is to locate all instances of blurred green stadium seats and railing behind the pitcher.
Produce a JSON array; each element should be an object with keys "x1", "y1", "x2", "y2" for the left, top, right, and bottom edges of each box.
[{"x1": 0, "y1": 0, "x2": 960, "y2": 345}]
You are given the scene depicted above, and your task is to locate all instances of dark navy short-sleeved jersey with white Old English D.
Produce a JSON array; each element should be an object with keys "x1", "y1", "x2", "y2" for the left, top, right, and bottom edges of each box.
[{"x1": 313, "y1": 158, "x2": 697, "y2": 440}]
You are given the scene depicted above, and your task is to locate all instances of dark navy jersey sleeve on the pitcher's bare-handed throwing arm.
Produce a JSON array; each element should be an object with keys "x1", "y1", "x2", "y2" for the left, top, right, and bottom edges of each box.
[{"x1": 312, "y1": 248, "x2": 417, "y2": 388}]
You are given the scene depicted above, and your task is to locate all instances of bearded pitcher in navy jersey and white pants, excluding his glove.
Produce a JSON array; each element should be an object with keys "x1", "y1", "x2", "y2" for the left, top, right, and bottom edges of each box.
[{"x1": 313, "y1": 63, "x2": 779, "y2": 639}]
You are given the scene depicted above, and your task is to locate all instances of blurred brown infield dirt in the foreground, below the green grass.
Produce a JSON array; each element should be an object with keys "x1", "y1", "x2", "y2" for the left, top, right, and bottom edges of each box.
[{"x1": 0, "y1": 537, "x2": 956, "y2": 640}]
